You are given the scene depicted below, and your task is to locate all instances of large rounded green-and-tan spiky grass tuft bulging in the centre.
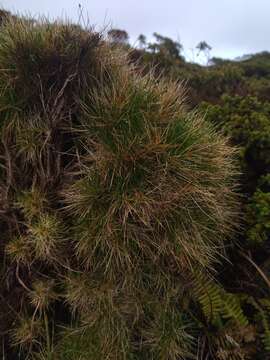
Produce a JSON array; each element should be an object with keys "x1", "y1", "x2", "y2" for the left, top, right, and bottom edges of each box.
[{"x1": 65, "y1": 74, "x2": 235, "y2": 271}]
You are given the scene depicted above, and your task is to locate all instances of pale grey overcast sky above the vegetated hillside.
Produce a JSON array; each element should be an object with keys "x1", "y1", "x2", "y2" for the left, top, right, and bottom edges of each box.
[{"x1": 0, "y1": 0, "x2": 270, "y2": 58}]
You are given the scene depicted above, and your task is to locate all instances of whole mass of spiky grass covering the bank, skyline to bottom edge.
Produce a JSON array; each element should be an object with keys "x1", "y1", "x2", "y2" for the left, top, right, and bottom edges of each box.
[{"x1": 0, "y1": 12, "x2": 240, "y2": 360}]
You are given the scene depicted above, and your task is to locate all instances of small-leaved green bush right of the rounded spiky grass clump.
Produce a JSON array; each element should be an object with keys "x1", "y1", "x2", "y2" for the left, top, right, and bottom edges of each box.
[{"x1": 201, "y1": 96, "x2": 270, "y2": 251}]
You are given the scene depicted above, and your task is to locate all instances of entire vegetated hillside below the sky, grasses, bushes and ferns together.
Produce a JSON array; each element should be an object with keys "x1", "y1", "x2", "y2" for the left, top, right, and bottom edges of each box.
[{"x1": 0, "y1": 12, "x2": 270, "y2": 360}]
